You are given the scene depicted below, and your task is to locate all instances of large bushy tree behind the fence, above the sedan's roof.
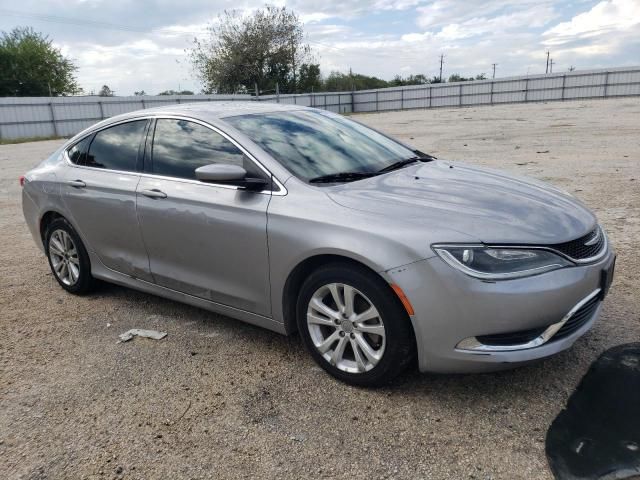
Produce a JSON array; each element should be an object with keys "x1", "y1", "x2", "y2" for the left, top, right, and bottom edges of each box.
[{"x1": 190, "y1": 6, "x2": 311, "y2": 93}]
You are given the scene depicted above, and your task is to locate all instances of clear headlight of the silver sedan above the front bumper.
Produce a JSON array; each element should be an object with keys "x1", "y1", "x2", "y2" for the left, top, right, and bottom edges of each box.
[{"x1": 433, "y1": 245, "x2": 574, "y2": 280}]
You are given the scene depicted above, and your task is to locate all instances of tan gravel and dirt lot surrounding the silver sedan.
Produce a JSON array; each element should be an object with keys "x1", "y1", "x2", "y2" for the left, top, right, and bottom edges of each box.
[{"x1": 0, "y1": 99, "x2": 640, "y2": 479}]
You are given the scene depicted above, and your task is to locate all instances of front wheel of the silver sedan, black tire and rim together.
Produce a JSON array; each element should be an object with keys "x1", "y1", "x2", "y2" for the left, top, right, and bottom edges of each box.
[{"x1": 297, "y1": 264, "x2": 415, "y2": 387}]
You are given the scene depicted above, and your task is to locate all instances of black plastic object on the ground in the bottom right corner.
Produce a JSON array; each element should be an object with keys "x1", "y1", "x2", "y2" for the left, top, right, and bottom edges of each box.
[{"x1": 546, "y1": 343, "x2": 640, "y2": 480}]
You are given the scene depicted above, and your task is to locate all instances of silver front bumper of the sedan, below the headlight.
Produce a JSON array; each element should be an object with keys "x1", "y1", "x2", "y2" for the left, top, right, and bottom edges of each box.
[{"x1": 386, "y1": 249, "x2": 615, "y2": 373}]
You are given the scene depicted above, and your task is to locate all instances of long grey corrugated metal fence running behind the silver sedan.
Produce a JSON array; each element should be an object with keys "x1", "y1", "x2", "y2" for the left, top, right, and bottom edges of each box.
[{"x1": 0, "y1": 67, "x2": 640, "y2": 139}]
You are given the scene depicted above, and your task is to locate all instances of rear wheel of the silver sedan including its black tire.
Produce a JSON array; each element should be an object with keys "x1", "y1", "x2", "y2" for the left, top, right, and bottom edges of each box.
[{"x1": 44, "y1": 218, "x2": 95, "y2": 295}]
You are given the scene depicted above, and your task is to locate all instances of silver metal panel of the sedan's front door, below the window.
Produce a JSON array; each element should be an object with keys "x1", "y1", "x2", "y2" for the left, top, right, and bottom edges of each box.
[{"x1": 137, "y1": 177, "x2": 271, "y2": 316}]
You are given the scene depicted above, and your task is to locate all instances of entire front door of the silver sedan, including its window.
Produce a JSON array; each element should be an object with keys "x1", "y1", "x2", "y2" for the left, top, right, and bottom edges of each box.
[{"x1": 137, "y1": 118, "x2": 271, "y2": 316}]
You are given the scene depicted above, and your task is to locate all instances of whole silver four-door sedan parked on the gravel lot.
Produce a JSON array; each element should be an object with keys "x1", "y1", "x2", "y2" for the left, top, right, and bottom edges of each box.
[{"x1": 21, "y1": 102, "x2": 615, "y2": 386}]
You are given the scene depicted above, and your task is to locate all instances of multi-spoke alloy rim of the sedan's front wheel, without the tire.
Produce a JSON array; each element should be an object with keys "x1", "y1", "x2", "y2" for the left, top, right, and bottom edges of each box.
[{"x1": 307, "y1": 283, "x2": 386, "y2": 373}]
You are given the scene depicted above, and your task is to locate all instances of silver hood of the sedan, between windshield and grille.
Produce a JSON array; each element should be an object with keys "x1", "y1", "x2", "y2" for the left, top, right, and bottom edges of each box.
[{"x1": 326, "y1": 160, "x2": 596, "y2": 244}]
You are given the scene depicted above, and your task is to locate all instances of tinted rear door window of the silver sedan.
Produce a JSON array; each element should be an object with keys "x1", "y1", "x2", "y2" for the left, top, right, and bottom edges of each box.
[{"x1": 85, "y1": 120, "x2": 147, "y2": 172}]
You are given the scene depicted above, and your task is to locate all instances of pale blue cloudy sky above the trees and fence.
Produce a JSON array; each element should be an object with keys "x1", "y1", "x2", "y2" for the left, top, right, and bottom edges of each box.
[{"x1": 0, "y1": 0, "x2": 640, "y2": 95}]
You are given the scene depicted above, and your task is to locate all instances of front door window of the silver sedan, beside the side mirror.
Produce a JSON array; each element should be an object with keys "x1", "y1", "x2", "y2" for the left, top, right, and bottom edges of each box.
[{"x1": 152, "y1": 119, "x2": 249, "y2": 179}]
